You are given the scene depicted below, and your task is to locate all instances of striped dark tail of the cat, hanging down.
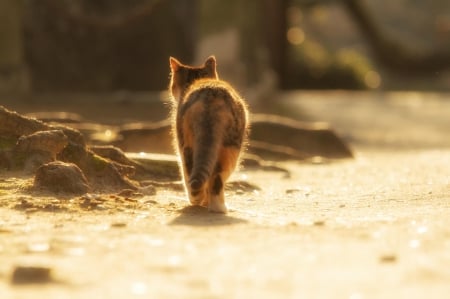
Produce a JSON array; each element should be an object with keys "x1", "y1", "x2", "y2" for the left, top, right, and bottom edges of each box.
[{"x1": 189, "y1": 122, "x2": 222, "y2": 192}]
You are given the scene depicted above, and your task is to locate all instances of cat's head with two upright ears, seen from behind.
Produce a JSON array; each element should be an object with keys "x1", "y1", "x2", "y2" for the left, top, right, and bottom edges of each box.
[{"x1": 169, "y1": 56, "x2": 219, "y2": 100}]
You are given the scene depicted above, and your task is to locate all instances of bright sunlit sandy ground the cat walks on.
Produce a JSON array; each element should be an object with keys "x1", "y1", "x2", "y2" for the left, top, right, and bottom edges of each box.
[{"x1": 0, "y1": 93, "x2": 450, "y2": 299}]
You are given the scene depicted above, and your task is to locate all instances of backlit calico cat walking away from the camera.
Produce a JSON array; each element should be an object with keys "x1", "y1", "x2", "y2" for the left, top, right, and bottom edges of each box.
[{"x1": 169, "y1": 56, "x2": 248, "y2": 213}]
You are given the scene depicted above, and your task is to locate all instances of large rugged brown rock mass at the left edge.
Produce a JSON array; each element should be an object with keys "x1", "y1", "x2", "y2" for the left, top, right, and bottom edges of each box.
[{"x1": 0, "y1": 106, "x2": 145, "y2": 193}]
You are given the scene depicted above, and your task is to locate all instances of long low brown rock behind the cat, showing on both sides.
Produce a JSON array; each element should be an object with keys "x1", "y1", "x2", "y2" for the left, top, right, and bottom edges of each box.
[{"x1": 113, "y1": 114, "x2": 353, "y2": 161}]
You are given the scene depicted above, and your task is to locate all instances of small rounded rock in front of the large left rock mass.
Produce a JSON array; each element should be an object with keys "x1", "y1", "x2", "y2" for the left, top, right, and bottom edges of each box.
[{"x1": 34, "y1": 161, "x2": 90, "y2": 195}]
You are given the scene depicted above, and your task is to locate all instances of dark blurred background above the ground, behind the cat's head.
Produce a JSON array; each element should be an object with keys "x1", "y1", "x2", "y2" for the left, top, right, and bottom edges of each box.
[{"x1": 0, "y1": 0, "x2": 450, "y2": 93}]
